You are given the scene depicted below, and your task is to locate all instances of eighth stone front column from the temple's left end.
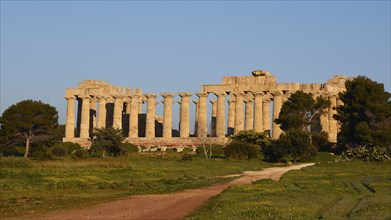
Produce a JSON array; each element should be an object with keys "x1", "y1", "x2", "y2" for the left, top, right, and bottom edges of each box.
[{"x1": 178, "y1": 92, "x2": 192, "y2": 138}]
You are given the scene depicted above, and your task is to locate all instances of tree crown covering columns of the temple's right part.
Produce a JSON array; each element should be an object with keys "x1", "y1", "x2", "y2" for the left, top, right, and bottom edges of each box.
[{"x1": 275, "y1": 91, "x2": 330, "y2": 132}]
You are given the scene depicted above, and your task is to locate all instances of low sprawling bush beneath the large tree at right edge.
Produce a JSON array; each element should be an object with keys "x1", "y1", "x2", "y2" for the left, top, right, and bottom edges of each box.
[{"x1": 342, "y1": 146, "x2": 391, "y2": 162}]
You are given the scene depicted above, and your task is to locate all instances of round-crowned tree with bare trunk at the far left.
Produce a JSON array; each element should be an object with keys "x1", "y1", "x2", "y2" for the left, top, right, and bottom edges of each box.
[{"x1": 0, "y1": 100, "x2": 58, "y2": 158}]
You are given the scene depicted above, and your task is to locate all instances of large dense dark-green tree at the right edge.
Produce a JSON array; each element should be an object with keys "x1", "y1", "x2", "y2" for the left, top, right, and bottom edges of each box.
[{"x1": 334, "y1": 76, "x2": 391, "y2": 147}]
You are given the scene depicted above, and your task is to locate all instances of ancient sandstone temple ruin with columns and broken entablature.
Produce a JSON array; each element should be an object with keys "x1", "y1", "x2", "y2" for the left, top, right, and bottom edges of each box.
[{"x1": 63, "y1": 70, "x2": 349, "y2": 146}]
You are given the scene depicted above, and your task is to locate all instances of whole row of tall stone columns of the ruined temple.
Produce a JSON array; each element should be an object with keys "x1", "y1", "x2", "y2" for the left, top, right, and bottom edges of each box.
[{"x1": 65, "y1": 91, "x2": 338, "y2": 140}]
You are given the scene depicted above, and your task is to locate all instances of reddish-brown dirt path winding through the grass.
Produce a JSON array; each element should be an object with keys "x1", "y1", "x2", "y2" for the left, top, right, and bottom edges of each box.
[{"x1": 15, "y1": 163, "x2": 314, "y2": 220}]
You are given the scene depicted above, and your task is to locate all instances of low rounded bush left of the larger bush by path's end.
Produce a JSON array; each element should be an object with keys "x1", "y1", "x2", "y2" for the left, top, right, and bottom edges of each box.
[{"x1": 224, "y1": 141, "x2": 260, "y2": 160}]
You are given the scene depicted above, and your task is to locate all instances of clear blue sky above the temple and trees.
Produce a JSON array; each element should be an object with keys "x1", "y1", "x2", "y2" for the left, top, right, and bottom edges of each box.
[{"x1": 0, "y1": 0, "x2": 391, "y2": 123}]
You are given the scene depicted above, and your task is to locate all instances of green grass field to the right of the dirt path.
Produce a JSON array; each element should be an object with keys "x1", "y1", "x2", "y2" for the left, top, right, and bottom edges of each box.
[{"x1": 187, "y1": 154, "x2": 391, "y2": 219}]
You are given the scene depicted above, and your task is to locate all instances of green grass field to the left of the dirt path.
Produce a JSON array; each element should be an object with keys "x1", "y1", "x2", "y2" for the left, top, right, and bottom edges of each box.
[{"x1": 0, "y1": 153, "x2": 271, "y2": 217}]
